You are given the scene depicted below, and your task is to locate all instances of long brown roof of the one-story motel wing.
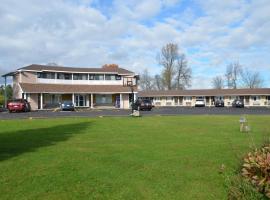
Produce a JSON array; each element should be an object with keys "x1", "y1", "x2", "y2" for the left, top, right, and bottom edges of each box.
[{"x1": 138, "y1": 88, "x2": 270, "y2": 97}]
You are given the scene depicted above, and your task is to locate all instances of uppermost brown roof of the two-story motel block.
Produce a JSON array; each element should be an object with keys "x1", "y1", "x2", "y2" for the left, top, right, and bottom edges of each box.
[{"x1": 18, "y1": 64, "x2": 134, "y2": 75}]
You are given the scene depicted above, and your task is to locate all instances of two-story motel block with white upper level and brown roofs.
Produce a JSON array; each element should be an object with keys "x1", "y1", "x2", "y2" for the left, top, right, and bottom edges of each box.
[{"x1": 3, "y1": 64, "x2": 138, "y2": 110}]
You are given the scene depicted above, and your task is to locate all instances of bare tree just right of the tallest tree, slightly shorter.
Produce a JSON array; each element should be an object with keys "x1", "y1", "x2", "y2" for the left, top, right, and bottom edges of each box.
[{"x1": 176, "y1": 54, "x2": 192, "y2": 90}]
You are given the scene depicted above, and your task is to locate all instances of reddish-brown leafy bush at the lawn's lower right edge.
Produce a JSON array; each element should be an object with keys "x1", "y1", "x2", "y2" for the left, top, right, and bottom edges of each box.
[{"x1": 242, "y1": 144, "x2": 270, "y2": 198}]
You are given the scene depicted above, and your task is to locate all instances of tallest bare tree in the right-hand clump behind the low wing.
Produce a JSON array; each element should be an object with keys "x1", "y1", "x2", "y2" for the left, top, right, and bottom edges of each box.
[{"x1": 225, "y1": 62, "x2": 242, "y2": 89}]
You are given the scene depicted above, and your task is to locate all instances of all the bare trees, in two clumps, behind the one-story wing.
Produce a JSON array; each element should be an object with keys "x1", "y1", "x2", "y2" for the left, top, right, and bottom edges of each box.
[{"x1": 139, "y1": 43, "x2": 263, "y2": 90}]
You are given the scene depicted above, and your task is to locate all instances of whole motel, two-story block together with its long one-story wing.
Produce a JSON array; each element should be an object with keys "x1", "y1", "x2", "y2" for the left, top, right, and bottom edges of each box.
[{"x1": 3, "y1": 64, "x2": 270, "y2": 110}]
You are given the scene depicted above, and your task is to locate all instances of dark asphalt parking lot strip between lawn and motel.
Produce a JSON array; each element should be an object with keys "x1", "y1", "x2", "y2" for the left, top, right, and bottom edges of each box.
[{"x1": 0, "y1": 107, "x2": 270, "y2": 120}]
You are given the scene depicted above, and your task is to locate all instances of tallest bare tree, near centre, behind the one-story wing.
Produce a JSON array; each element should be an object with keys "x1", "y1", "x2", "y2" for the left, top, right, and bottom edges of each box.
[{"x1": 158, "y1": 43, "x2": 178, "y2": 90}]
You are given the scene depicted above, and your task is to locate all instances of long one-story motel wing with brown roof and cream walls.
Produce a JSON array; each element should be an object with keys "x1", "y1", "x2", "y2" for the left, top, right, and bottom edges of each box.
[{"x1": 138, "y1": 88, "x2": 270, "y2": 107}]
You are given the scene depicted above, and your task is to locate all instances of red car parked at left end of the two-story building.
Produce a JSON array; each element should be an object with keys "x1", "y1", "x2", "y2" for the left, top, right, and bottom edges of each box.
[{"x1": 7, "y1": 99, "x2": 31, "y2": 112}]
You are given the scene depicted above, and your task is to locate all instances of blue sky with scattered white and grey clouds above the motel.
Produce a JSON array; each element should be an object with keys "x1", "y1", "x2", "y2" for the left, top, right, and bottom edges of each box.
[{"x1": 0, "y1": 0, "x2": 270, "y2": 88}]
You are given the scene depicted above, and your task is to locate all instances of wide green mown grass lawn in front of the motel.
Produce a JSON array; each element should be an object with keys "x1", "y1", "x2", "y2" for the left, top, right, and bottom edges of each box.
[{"x1": 0, "y1": 116, "x2": 270, "y2": 200}]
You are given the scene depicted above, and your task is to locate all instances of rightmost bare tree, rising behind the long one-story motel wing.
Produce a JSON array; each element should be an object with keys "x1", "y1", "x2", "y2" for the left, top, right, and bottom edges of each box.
[{"x1": 241, "y1": 70, "x2": 263, "y2": 88}]
